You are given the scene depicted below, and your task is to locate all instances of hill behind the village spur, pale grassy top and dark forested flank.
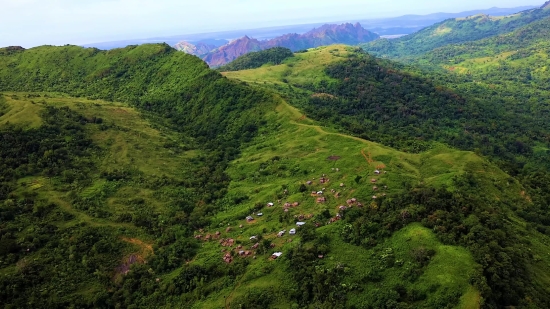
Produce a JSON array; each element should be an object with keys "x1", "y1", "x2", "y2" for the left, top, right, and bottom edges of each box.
[{"x1": 224, "y1": 46, "x2": 550, "y2": 174}]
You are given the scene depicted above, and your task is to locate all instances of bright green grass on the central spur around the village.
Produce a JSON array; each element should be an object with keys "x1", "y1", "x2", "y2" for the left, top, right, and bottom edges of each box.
[{"x1": 178, "y1": 95, "x2": 492, "y2": 308}]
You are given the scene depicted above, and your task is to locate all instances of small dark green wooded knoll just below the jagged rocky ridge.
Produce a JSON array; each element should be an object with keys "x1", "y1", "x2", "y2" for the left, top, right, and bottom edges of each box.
[{"x1": 218, "y1": 47, "x2": 294, "y2": 72}]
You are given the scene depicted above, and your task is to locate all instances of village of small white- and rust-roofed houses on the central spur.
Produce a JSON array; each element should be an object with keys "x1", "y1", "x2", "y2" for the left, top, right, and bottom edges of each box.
[{"x1": 195, "y1": 166, "x2": 388, "y2": 263}]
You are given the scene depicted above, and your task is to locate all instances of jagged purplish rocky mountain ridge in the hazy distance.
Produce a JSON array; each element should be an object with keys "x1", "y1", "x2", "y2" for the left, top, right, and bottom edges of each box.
[{"x1": 174, "y1": 23, "x2": 380, "y2": 67}]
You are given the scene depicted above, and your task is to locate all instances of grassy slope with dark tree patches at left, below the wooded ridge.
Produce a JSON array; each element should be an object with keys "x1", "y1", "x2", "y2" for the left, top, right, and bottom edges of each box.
[{"x1": 0, "y1": 93, "x2": 207, "y2": 308}]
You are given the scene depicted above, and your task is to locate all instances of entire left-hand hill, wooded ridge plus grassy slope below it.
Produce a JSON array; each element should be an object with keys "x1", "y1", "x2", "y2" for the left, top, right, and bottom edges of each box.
[{"x1": 0, "y1": 45, "x2": 274, "y2": 308}]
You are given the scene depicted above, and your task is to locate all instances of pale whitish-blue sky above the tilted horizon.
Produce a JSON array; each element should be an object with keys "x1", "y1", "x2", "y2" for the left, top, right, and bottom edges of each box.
[{"x1": 0, "y1": 0, "x2": 545, "y2": 48}]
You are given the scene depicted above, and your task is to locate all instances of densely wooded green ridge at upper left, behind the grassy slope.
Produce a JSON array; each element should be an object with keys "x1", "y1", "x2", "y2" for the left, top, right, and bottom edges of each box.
[{"x1": 0, "y1": 44, "x2": 274, "y2": 147}]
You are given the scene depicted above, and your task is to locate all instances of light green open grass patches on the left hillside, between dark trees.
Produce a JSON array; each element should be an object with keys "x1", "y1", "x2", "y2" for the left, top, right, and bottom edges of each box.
[{"x1": 0, "y1": 93, "x2": 199, "y2": 234}]
